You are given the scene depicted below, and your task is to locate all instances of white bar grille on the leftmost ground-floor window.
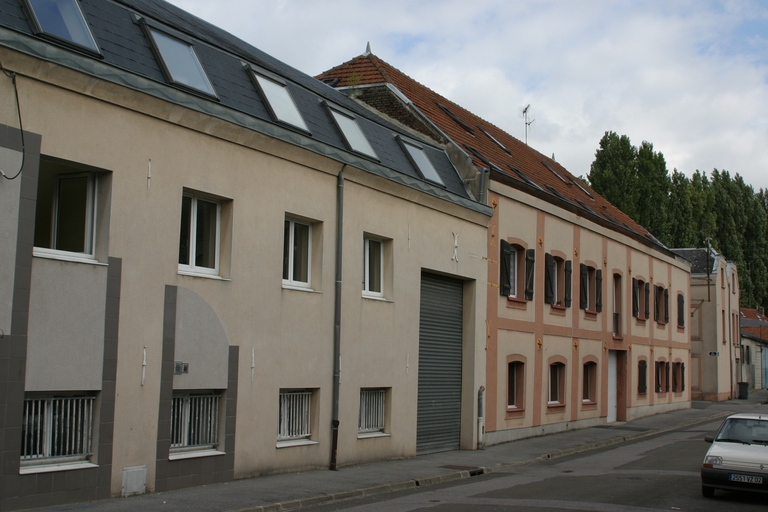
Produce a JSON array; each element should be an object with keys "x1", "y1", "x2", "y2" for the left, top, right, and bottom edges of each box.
[{"x1": 21, "y1": 397, "x2": 94, "y2": 461}]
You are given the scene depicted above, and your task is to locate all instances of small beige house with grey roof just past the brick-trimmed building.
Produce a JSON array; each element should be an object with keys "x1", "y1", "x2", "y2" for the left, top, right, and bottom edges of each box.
[{"x1": 674, "y1": 249, "x2": 741, "y2": 401}]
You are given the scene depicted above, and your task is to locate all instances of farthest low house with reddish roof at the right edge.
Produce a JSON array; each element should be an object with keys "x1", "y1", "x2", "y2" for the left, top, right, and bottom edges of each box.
[{"x1": 739, "y1": 308, "x2": 768, "y2": 389}]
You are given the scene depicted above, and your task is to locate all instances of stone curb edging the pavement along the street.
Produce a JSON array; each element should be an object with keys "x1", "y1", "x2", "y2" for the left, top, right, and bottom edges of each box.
[{"x1": 228, "y1": 411, "x2": 733, "y2": 512}]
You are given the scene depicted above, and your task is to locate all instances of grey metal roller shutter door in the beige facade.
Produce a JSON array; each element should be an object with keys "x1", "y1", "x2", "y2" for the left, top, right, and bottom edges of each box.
[{"x1": 416, "y1": 273, "x2": 464, "y2": 454}]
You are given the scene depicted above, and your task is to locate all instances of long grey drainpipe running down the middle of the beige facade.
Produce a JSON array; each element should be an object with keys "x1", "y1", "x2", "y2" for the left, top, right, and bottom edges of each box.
[{"x1": 330, "y1": 164, "x2": 347, "y2": 471}]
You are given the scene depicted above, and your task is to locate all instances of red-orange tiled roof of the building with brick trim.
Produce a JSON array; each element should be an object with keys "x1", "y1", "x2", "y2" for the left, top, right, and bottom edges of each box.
[{"x1": 316, "y1": 53, "x2": 666, "y2": 250}]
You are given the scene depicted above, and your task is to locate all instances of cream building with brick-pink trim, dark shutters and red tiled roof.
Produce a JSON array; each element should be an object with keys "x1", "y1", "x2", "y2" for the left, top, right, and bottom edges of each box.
[{"x1": 317, "y1": 51, "x2": 691, "y2": 444}]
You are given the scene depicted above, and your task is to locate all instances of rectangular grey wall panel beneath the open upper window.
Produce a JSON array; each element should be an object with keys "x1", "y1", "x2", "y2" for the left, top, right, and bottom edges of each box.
[{"x1": 26, "y1": 258, "x2": 107, "y2": 391}]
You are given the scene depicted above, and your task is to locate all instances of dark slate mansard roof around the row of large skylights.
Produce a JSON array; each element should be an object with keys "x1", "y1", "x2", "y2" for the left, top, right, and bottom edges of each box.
[{"x1": 0, "y1": 0, "x2": 480, "y2": 210}]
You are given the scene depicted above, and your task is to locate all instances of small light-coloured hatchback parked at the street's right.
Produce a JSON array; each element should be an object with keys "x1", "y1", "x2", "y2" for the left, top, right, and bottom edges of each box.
[{"x1": 701, "y1": 414, "x2": 768, "y2": 498}]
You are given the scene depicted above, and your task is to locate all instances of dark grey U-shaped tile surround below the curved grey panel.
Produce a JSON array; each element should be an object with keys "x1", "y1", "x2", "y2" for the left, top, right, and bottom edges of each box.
[{"x1": 155, "y1": 286, "x2": 240, "y2": 492}]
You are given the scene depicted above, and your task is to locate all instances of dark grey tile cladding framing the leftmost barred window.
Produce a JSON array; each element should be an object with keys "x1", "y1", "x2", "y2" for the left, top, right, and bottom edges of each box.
[{"x1": 0, "y1": 125, "x2": 122, "y2": 511}]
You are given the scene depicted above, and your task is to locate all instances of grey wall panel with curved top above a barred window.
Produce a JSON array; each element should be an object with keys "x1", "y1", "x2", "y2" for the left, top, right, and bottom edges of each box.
[{"x1": 173, "y1": 287, "x2": 229, "y2": 389}]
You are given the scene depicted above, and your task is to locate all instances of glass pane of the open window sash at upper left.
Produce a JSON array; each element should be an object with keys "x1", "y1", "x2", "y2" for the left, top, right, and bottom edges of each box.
[{"x1": 53, "y1": 176, "x2": 88, "y2": 252}]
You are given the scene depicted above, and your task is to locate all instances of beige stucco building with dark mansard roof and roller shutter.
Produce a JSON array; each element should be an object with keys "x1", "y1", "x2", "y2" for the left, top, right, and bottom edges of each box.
[{"x1": 0, "y1": 0, "x2": 492, "y2": 510}]
